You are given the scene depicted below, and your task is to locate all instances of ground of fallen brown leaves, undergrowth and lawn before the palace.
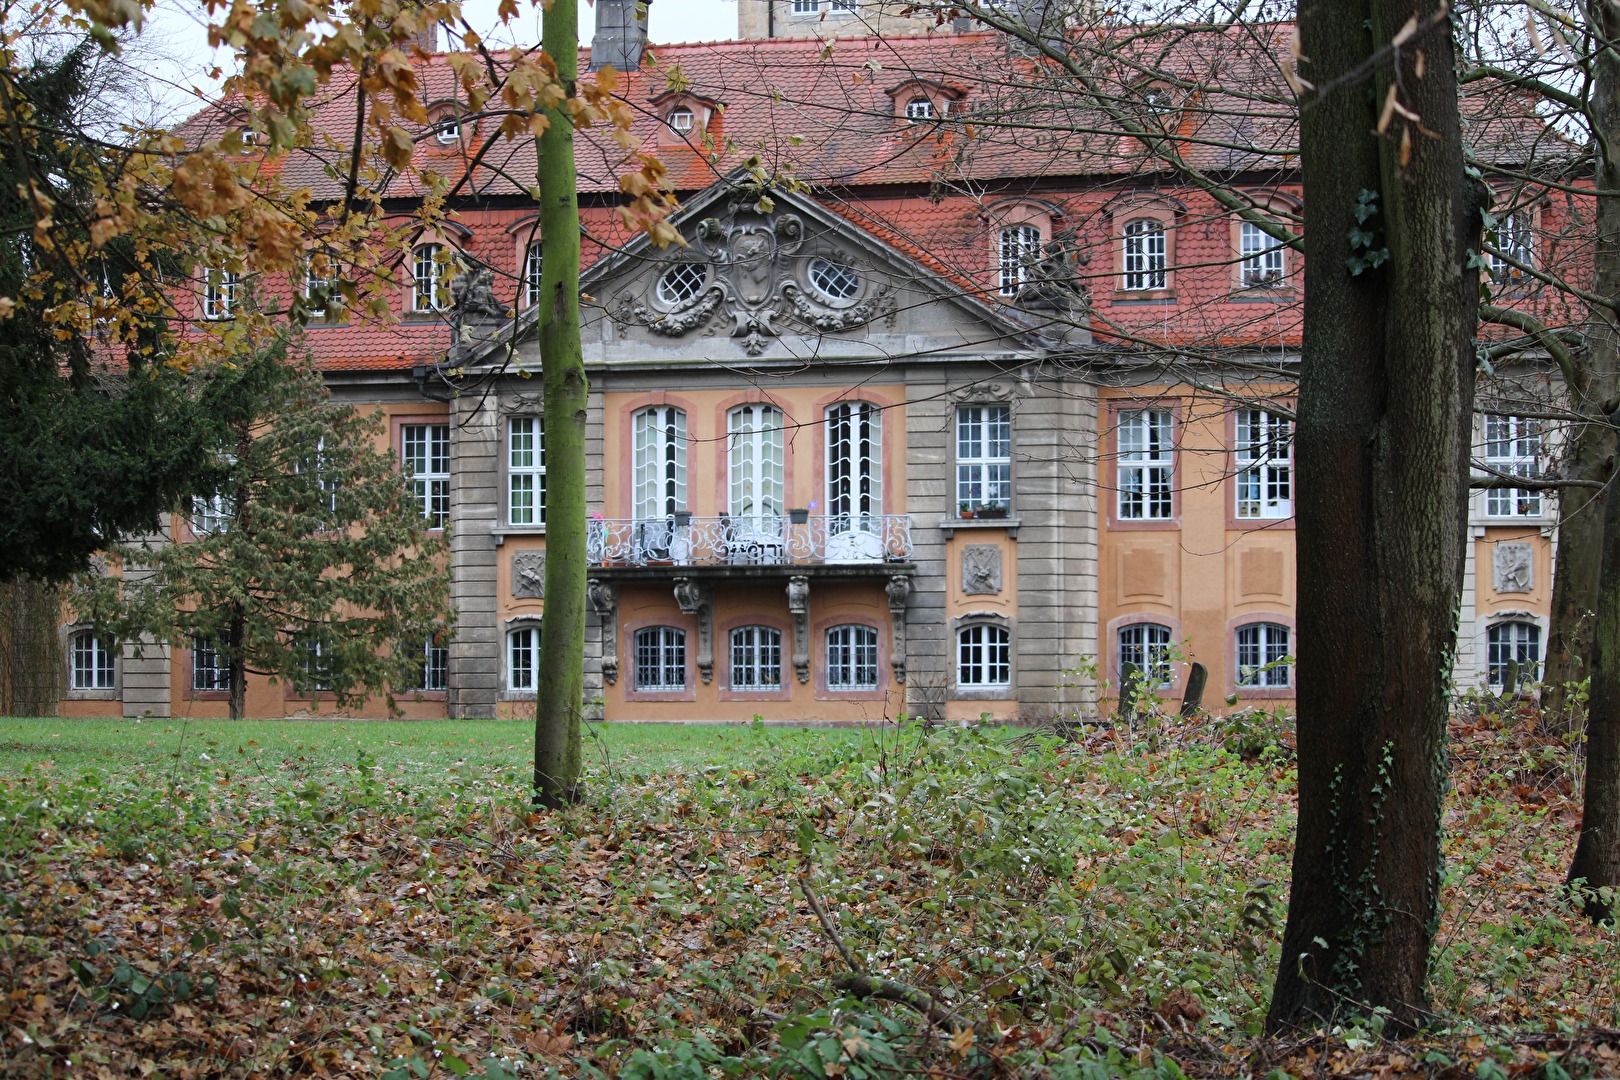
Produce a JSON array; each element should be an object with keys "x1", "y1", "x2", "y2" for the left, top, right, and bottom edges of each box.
[{"x1": 0, "y1": 716, "x2": 1620, "y2": 1080}]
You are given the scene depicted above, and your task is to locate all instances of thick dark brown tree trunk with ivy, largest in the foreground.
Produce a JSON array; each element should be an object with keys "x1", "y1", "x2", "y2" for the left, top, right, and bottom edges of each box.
[{"x1": 1267, "y1": 0, "x2": 1484, "y2": 1031}]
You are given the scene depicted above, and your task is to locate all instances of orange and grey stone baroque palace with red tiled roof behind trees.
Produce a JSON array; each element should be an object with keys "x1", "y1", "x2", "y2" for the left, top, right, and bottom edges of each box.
[{"x1": 63, "y1": 0, "x2": 1570, "y2": 721}]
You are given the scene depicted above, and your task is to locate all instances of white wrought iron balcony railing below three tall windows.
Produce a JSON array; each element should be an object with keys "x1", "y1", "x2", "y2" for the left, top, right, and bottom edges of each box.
[{"x1": 586, "y1": 513, "x2": 912, "y2": 567}]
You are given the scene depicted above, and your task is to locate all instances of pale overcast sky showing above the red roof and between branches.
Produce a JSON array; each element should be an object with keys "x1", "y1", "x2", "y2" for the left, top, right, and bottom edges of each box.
[{"x1": 141, "y1": 0, "x2": 738, "y2": 120}]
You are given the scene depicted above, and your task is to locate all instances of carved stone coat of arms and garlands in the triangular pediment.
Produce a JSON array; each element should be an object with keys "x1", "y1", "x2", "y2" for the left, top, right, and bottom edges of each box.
[{"x1": 614, "y1": 194, "x2": 896, "y2": 356}]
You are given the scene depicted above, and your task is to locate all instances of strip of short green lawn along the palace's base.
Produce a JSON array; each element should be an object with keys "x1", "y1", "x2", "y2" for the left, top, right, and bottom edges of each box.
[{"x1": 0, "y1": 717, "x2": 874, "y2": 776}]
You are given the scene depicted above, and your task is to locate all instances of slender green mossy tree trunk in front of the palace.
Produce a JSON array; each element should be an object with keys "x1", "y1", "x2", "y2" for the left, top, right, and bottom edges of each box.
[{"x1": 535, "y1": 0, "x2": 590, "y2": 806}]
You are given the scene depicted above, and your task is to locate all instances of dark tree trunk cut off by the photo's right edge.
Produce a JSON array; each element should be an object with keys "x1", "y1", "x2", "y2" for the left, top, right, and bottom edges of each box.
[{"x1": 1554, "y1": 3, "x2": 1620, "y2": 920}]
